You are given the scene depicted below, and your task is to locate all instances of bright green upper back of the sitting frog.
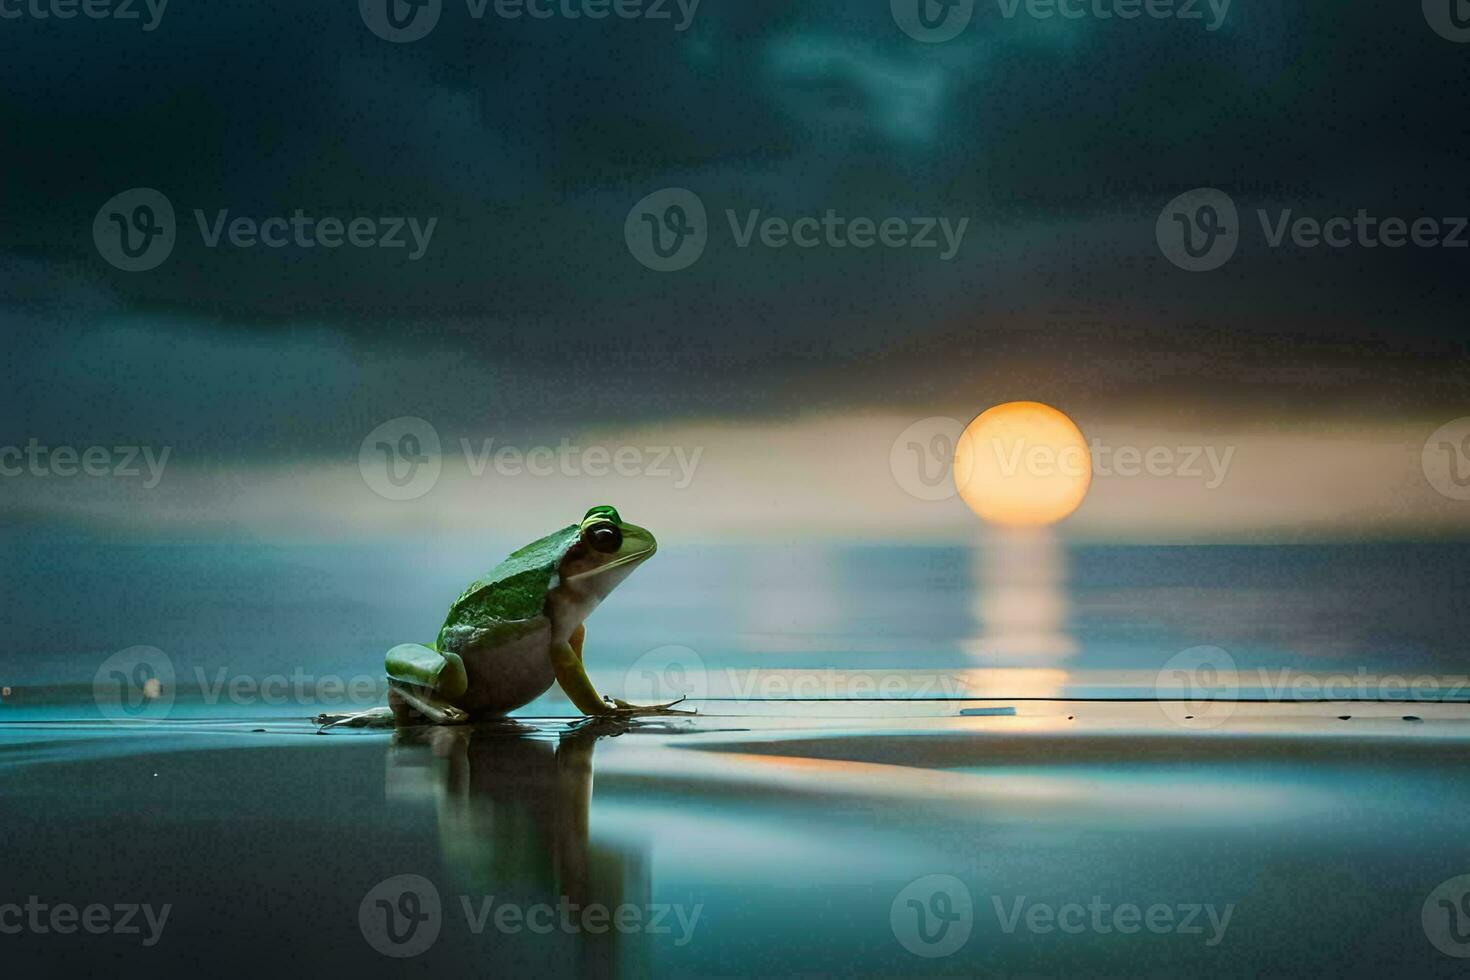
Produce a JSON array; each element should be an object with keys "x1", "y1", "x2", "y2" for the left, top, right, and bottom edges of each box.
[{"x1": 440, "y1": 525, "x2": 578, "y2": 649}]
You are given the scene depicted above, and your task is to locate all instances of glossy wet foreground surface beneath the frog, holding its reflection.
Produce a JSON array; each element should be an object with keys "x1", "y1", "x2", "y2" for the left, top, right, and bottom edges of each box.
[{"x1": 0, "y1": 702, "x2": 1470, "y2": 977}]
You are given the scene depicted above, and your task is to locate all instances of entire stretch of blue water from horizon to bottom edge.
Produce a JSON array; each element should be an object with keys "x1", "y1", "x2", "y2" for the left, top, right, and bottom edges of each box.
[{"x1": 0, "y1": 530, "x2": 1470, "y2": 977}]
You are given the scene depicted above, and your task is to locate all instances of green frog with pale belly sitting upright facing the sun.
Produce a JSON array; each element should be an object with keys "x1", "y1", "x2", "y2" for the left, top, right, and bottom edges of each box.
[{"x1": 367, "y1": 504, "x2": 692, "y2": 726}]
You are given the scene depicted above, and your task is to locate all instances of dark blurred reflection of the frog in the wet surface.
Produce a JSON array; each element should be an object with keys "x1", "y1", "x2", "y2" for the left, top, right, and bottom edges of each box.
[{"x1": 387, "y1": 721, "x2": 650, "y2": 908}]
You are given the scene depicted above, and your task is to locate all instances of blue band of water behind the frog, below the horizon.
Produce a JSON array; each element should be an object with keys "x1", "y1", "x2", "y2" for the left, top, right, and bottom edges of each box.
[{"x1": 0, "y1": 529, "x2": 1470, "y2": 714}]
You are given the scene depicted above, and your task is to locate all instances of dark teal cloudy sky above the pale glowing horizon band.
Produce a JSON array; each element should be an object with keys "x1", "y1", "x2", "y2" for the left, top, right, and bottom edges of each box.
[{"x1": 0, "y1": 0, "x2": 1470, "y2": 455}]
